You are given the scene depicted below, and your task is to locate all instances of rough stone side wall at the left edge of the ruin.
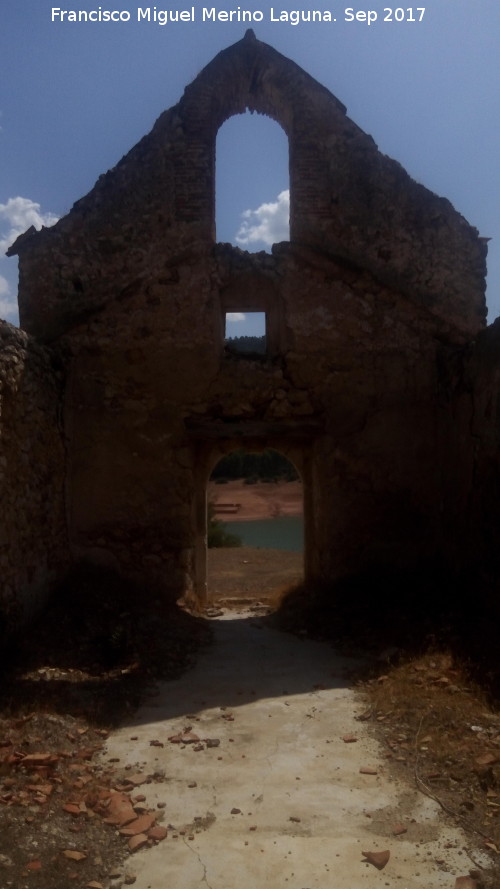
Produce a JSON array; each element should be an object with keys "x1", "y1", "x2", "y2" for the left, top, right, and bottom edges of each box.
[{"x1": 0, "y1": 321, "x2": 69, "y2": 630}]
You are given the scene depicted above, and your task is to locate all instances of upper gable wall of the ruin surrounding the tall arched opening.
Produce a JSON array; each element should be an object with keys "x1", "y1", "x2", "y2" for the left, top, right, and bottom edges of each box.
[{"x1": 11, "y1": 36, "x2": 486, "y2": 340}]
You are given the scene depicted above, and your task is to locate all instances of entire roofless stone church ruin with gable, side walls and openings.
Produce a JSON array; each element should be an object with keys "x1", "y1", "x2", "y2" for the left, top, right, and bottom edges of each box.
[{"x1": 0, "y1": 31, "x2": 500, "y2": 626}]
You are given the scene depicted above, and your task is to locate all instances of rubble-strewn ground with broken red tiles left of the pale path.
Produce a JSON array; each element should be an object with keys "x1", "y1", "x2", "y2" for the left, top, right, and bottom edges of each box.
[{"x1": 0, "y1": 591, "x2": 209, "y2": 889}]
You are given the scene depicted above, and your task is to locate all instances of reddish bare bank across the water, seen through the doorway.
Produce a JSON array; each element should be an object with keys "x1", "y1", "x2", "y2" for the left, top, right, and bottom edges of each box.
[{"x1": 208, "y1": 479, "x2": 303, "y2": 522}]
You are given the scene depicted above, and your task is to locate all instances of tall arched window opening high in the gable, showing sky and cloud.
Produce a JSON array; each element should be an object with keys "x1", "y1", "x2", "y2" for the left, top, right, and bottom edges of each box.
[{"x1": 215, "y1": 112, "x2": 290, "y2": 253}]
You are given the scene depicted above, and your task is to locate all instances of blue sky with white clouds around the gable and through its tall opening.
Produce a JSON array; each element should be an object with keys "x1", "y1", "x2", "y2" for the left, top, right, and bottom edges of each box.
[{"x1": 0, "y1": 0, "x2": 500, "y2": 332}]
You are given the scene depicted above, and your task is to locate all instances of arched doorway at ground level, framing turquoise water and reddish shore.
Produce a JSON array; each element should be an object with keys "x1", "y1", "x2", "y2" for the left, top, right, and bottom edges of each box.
[{"x1": 207, "y1": 448, "x2": 304, "y2": 608}]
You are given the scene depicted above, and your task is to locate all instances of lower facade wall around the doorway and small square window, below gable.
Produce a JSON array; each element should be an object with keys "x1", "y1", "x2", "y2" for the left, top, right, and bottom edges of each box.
[{"x1": 54, "y1": 239, "x2": 469, "y2": 594}]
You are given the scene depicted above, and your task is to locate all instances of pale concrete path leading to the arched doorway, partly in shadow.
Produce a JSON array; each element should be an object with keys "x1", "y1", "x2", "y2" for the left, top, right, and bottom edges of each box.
[{"x1": 105, "y1": 612, "x2": 484, "y2": 889}]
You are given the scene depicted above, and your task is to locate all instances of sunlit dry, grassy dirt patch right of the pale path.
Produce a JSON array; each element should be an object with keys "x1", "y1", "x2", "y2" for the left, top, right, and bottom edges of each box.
[{"x1": 360, "y1": 650, "x2": 500, "y2": 889}]
